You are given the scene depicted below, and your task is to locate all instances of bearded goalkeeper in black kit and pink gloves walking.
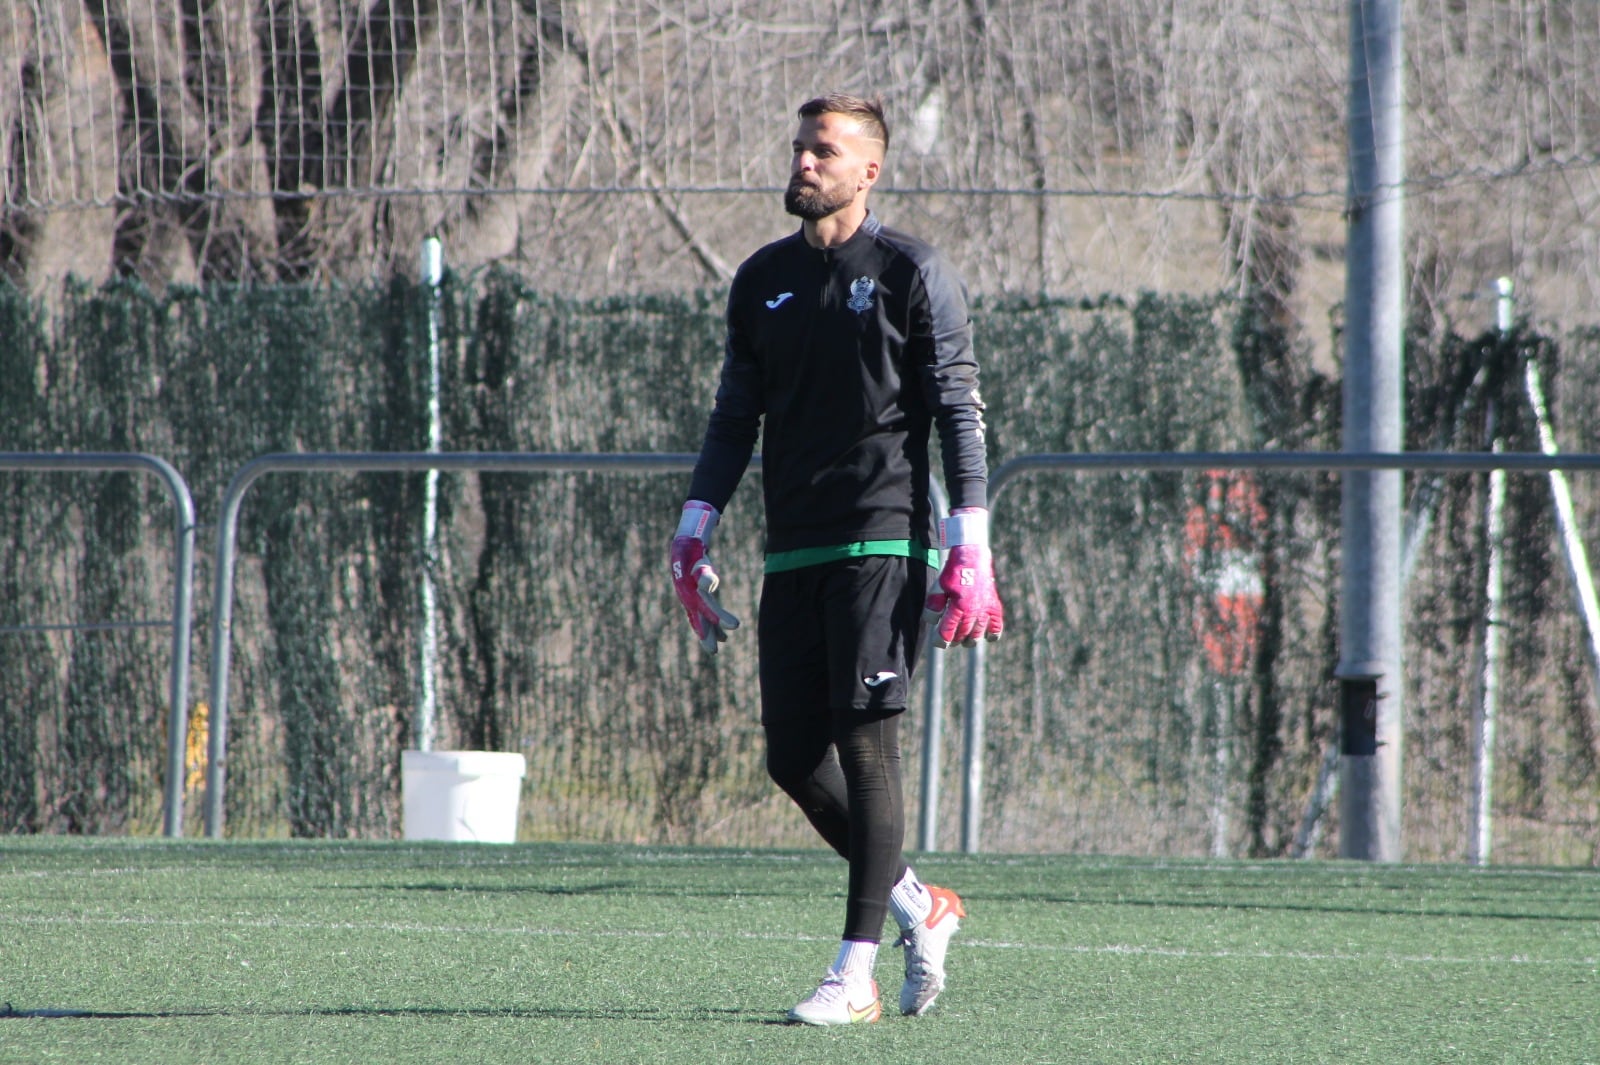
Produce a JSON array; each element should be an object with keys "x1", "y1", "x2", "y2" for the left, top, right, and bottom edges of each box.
[{"x1": 672, "y1": 94, "x2": 1003, "y2": 1025}]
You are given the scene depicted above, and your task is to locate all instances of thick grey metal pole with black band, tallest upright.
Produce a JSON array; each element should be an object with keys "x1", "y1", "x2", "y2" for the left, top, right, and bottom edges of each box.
[{"x1": 1334, "y1": 0, "x2": 1405, "y2": 862}]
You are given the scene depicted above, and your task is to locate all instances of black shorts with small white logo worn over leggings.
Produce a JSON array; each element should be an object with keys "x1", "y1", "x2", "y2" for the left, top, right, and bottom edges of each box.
[{"x1": 757, "y1": 555, "x2": 928, "y2": 724}]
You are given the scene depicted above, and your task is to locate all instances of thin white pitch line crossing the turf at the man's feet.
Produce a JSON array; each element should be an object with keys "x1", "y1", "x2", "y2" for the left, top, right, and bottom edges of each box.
[{"x1": 0, "y1": 913, "x2": 1600, "y2": 969}]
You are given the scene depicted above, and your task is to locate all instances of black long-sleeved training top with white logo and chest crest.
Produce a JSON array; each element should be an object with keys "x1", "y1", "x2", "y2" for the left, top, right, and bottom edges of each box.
[{"x1": 690, "y1": 213, "x2": 987, "y2": 553}]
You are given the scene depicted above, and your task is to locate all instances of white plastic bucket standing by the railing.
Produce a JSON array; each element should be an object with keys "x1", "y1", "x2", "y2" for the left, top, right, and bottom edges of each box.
[{"x1": 400, "y1": 750, "x2": 528, "y2": 843}]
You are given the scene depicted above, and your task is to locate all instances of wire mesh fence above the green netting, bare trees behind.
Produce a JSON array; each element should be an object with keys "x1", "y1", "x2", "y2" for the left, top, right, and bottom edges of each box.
[{"x1": 0, "y1": 0, "x2": 1600, "y2": 335}]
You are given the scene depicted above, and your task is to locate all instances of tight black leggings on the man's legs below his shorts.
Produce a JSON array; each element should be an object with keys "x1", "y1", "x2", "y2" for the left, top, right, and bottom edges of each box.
[{"x1": 766, "y1": 710, "x2": 906, "y2": 943}]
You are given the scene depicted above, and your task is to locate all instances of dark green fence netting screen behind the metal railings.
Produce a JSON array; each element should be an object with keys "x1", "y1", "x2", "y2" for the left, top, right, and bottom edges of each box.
[{"x1": 0, "y1": 272, "x2": 1600, "y2": 862}]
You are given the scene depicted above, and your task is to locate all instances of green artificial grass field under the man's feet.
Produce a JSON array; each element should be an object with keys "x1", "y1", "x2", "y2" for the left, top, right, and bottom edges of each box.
[{"x1": 0, "y1": 838, "x2": 1600, "y2": 1065}]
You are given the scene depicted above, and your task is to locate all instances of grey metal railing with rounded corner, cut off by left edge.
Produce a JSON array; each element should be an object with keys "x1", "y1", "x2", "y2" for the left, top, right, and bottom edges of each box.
[{"x1": 0, "y1": 451, "x2": 195, "y2": 836}]
